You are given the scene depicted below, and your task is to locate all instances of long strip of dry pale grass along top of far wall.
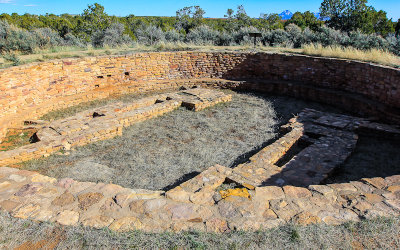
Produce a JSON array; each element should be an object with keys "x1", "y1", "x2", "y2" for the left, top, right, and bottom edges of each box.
[{"x1": 0, "y1": 42, "x2": 400, "y2": 68}]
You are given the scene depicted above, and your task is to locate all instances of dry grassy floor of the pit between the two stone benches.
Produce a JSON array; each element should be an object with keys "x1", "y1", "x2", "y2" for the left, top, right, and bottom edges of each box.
[{"x1": 19, "y1": 93, "x2": 340, "y2": 190}]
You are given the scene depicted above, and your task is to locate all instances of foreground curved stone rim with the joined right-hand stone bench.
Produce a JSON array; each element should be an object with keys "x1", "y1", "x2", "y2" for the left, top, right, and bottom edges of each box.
[{"x1": 0, "y1": 107, "x2": 400, "y2": 233}]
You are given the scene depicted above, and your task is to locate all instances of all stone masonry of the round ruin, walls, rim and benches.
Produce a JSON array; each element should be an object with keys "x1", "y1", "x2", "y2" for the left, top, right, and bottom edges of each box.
[{"x1": 0, "y1": 52, "x2": 400, "y2": 232}]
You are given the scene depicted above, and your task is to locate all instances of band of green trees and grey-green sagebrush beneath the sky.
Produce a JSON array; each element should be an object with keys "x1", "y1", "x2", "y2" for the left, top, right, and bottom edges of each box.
[{"x1": 0, "y1": 0, "x2": 400, "y2": 54}]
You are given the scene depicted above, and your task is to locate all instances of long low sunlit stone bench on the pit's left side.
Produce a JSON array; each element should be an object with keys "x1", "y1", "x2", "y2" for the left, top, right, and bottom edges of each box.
[{"x1": 0, "y1": 88, "x2": 232, "y2": 166}]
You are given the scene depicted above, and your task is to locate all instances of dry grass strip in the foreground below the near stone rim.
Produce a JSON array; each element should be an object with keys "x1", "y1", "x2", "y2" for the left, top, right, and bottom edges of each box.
[{"x1": 0, "y1": 212, "x2": 400, "y2": 249}]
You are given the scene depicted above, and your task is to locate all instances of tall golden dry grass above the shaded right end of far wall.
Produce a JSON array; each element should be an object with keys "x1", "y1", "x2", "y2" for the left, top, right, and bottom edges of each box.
[{"x1": 302, "y1": 44, "x2": 400, "y2": 66}]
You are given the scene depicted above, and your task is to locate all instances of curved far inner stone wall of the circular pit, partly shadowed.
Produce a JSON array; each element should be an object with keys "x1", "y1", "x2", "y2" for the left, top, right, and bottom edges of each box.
[{"x1": 0, "y1": 52, "x2": 400, "y2": 142}]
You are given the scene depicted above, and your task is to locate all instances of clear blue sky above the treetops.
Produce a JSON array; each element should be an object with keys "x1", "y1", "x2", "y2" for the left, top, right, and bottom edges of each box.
[{"x1": 0, "y1": 0, "x2": 400, "y2": 20}]
